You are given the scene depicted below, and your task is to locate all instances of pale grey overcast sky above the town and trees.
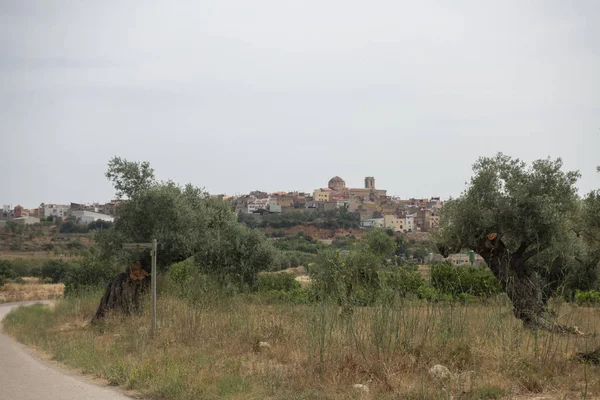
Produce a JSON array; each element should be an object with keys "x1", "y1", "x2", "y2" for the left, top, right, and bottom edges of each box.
[{"x1": 0, "y1": 0, "x2": 600, "y2": 207}]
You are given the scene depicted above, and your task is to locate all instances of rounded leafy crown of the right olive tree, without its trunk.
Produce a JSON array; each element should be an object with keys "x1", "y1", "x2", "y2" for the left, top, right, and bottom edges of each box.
[{"x1": 440, "y1": 154, "x2": 580, "y2": 251}]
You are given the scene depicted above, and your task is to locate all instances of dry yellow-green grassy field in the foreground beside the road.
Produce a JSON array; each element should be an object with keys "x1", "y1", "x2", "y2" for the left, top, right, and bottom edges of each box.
[{"x1": 5, "y1": 292, "x2": 600, "y2": 400}]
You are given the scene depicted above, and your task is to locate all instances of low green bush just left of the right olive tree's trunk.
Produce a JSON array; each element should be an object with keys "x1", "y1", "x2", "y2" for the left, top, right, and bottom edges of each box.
[{"x1": 431, "y1": 263, "x2": 500, "y2": 297}]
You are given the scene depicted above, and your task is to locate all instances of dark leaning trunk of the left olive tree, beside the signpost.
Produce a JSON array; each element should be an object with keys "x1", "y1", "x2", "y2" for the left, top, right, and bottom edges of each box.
[{"x1": 90, "y1": 260, "x2": 150, "y2": 324}]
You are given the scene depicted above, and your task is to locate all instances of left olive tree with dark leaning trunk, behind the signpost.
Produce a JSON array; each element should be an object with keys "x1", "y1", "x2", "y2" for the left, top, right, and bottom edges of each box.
[{"x1": 94, "y1": 157, "x2": 274, "y2": 321}]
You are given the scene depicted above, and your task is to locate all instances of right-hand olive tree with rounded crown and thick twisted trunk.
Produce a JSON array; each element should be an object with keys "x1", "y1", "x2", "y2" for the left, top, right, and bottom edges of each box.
[{"x1": 438, "y1": 154, "x2": 580, "y2": 330}]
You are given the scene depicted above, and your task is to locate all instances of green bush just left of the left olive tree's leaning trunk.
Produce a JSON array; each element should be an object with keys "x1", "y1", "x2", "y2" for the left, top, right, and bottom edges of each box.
[{"x1": 63, "y1": 257, "x2": 125, "y2": 296}]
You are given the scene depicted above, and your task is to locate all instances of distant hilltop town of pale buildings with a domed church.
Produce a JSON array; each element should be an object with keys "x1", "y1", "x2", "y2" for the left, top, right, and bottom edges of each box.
[{"x1": 0, "y1": 176, "x2": 444, "y2": 232}]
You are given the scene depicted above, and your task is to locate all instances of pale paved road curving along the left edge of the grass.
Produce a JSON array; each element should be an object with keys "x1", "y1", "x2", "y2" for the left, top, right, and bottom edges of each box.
[{"x1": 0, "y1": 302, "x2": 130, "y2": 400}]
